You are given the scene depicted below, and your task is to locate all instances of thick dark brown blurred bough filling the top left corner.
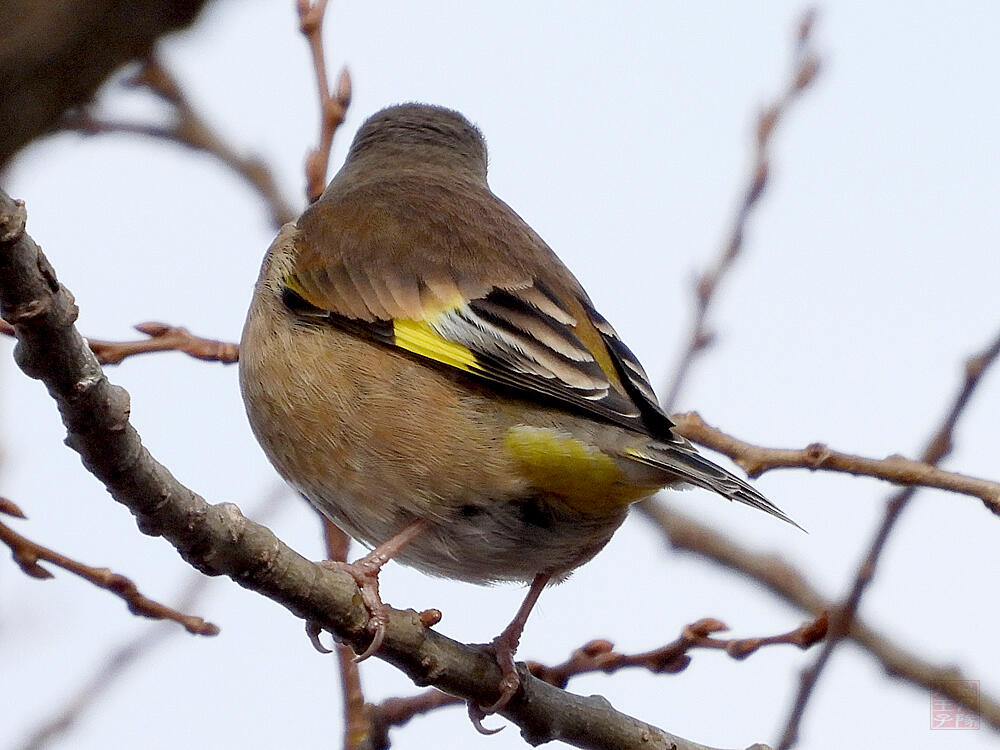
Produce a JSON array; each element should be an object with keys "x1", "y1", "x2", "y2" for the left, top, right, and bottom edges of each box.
[{"x1": 0, "y1": 0, "x2": 206, "y2": 168}]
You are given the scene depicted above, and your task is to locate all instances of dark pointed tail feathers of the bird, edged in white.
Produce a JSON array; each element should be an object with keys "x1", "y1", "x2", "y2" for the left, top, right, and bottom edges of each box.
[{"x1": 628, "y1": 439, "x2": 805, "y2": 531}]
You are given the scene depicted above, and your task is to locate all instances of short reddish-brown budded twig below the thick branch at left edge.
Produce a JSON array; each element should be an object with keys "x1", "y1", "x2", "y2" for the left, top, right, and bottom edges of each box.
[{"x1": 0, "y1": 506, "x2": 219, "y2": 635}]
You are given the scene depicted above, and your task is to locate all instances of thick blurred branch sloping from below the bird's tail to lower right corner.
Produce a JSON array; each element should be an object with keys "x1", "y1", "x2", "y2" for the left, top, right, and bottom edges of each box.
[{"x1": 639, "y1": 500, "x2": 1000, "y2": 730}]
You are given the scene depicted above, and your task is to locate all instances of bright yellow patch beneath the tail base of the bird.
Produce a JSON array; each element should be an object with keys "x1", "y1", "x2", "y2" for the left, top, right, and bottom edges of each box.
[{"x1": 504, "y1": 425, "x2": 656, "y2": 515}]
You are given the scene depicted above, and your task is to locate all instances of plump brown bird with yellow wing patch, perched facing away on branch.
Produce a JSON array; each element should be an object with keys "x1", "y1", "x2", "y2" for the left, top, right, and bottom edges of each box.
[{"x1": 239, "y1": 103, "x2": 794, "y2": 712}]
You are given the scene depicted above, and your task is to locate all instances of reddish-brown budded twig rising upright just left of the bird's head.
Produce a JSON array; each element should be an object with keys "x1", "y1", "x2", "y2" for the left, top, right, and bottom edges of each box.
[{"x1": 297, "y1": 0, "x2": 351, "y2": 203}]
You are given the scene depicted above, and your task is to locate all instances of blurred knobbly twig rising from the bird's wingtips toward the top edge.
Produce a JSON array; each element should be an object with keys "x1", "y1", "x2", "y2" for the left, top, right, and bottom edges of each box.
[{"x1": 663, "y1": 9, "x2": 820, "y2": 414}]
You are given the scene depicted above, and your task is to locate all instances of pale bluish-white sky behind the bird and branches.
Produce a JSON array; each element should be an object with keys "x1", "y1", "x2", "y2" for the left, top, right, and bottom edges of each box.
[{"x1": 0, "y1": 0, "x2": 1000, "y2": 750}]
